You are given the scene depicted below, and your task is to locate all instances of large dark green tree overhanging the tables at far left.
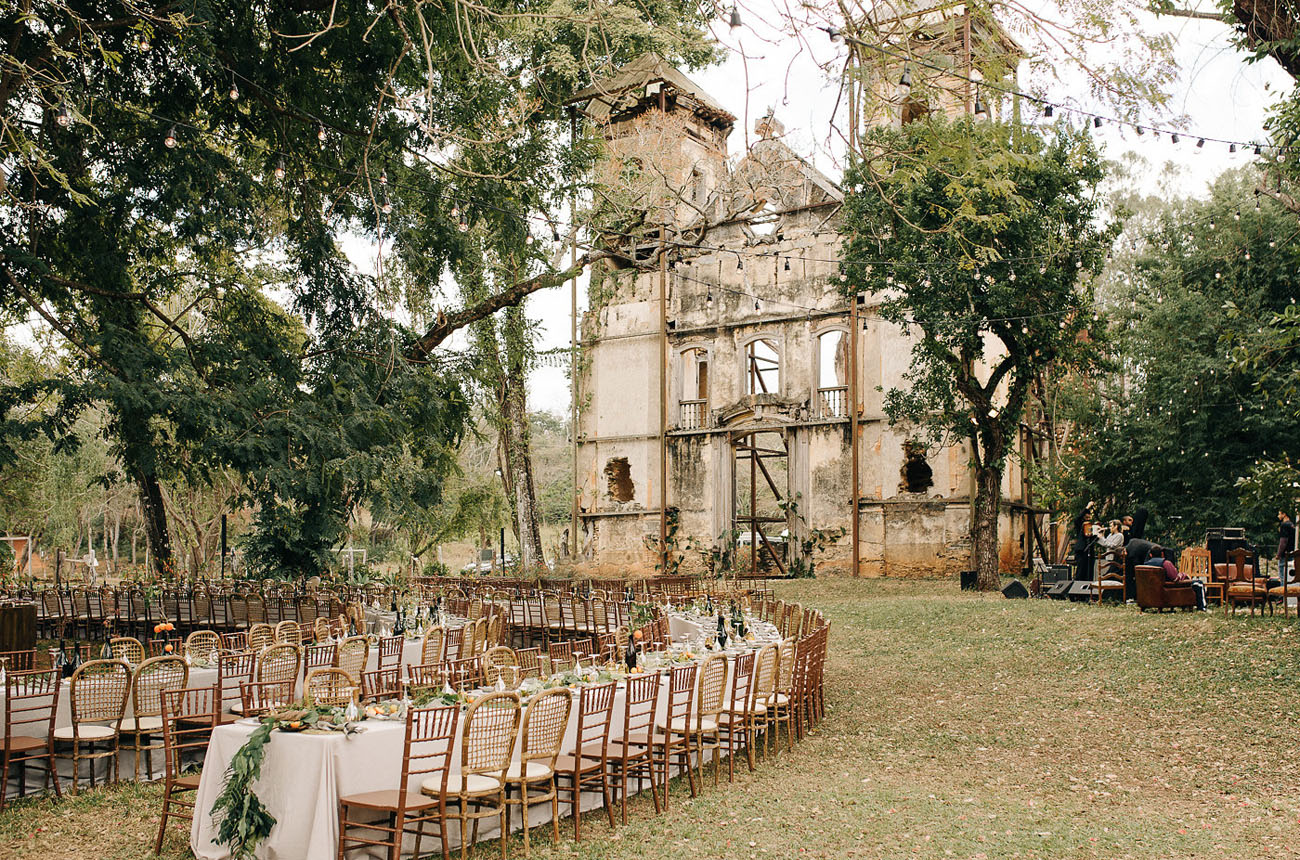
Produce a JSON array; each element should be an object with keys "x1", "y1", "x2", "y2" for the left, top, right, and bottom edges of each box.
[{"x1": 0, "y1": 0, "x2": 712, "y2": 579}]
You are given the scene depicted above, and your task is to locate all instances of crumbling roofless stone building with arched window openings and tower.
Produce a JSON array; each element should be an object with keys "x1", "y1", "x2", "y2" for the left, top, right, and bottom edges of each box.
[{"x1": 575, "y1": 8, "x2": 1045, "y2": 575}]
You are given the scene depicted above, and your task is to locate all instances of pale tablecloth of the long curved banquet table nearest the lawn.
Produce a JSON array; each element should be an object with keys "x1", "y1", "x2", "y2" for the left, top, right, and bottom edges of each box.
[{"x1": 190, "y1": 614, "x2": 777, "y2": 860}]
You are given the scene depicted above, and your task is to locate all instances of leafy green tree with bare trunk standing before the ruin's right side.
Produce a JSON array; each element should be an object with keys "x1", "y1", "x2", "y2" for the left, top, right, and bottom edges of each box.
[{"x1": 842, "y1": 117, "x2": 1110, "y2": 588}]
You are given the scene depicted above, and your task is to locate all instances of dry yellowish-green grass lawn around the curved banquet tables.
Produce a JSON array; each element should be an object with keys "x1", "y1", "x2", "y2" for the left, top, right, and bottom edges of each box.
[{"x1": 0, "y1": 579, "x2": 1300, "y2": 860}]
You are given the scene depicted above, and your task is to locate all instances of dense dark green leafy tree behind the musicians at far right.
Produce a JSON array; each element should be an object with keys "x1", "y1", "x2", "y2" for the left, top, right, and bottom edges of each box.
[{"x1": 1037, "y1": 170, "x2": 1300, "y2": 544}]
